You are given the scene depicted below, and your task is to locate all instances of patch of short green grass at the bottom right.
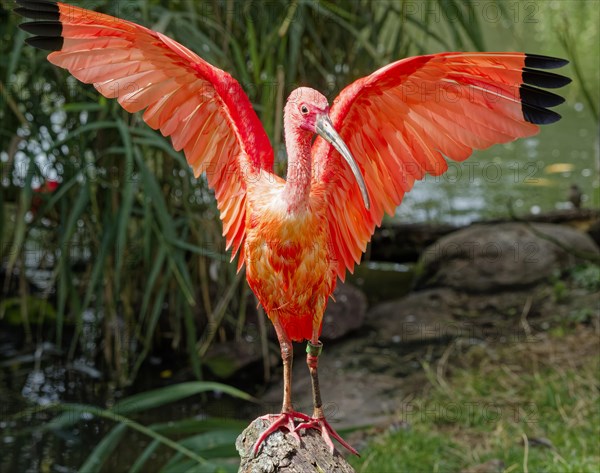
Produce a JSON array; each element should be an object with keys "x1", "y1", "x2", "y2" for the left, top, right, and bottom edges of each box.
[{"x1": 351, "y1": 328, "x2": 600, "y2": 473}]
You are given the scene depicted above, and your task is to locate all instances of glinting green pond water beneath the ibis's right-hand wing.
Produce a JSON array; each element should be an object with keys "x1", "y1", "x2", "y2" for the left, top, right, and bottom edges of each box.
[{"x1": 394, "y1": 102, "x2": 600, "y2": 225}]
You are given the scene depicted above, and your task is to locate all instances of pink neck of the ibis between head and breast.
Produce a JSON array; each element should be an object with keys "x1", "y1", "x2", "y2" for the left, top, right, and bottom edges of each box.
[{"x1": 283, "y1": 127, "x2": 313, "y2": 212}]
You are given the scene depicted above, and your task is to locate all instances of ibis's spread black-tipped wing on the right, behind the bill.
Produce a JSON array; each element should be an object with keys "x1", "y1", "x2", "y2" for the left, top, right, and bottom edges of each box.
[{"x1": 312, "y1": 53, "x2": 570, "y2": 280}]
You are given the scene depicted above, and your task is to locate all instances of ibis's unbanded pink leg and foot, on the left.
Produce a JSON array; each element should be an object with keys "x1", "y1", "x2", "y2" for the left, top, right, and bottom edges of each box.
[{"x1": 253, "y1": 321, "x2": 310, "y2": 455}]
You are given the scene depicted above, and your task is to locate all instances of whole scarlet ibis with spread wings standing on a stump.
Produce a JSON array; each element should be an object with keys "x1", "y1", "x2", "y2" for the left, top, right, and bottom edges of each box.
[{"x1": 16, "y1": 0, "x2": 570, "y2": 453}]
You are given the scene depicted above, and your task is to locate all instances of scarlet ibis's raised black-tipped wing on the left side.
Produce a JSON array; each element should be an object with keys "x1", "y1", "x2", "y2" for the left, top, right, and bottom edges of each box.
[{"x1": 15, "y1": 0, "x2": 273, "y2": 266}]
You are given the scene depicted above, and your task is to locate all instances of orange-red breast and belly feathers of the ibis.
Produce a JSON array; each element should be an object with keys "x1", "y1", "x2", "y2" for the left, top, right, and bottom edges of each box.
[{"x1": 244, "y1": 183, "x2": 335, "y2": 336}]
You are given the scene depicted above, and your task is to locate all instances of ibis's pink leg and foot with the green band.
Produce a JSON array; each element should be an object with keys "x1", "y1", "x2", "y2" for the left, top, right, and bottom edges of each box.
[{"x1": 296, "y1": 336, "x2": 358, "y2": 455}]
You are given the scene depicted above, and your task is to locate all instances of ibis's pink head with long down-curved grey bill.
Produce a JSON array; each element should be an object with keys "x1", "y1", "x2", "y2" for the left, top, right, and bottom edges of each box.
[{"x1": 285, "y1": 87, "x2": 370, "y2": 209}]
